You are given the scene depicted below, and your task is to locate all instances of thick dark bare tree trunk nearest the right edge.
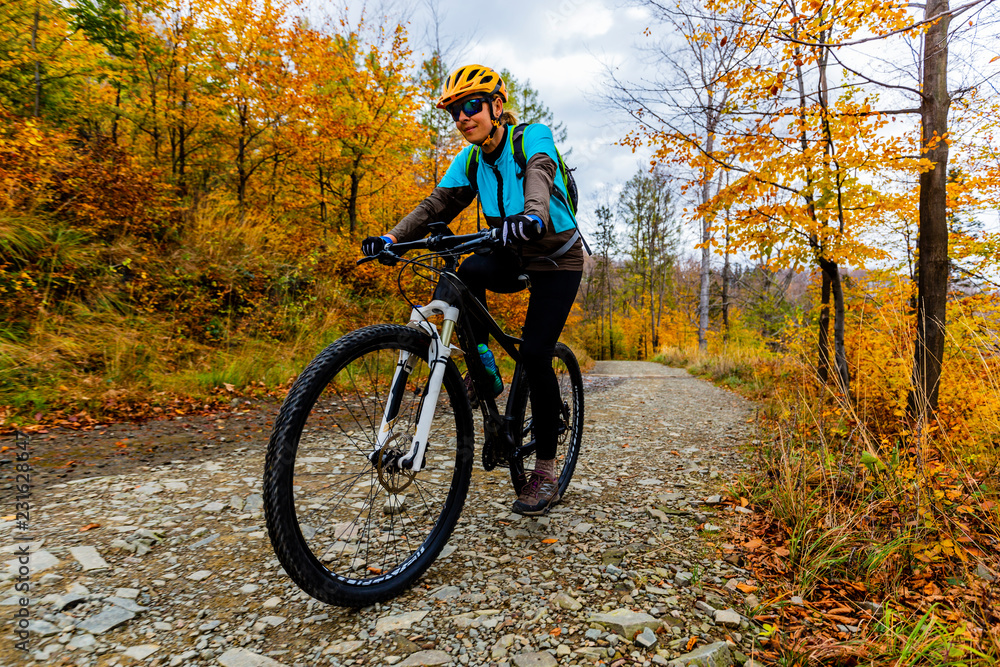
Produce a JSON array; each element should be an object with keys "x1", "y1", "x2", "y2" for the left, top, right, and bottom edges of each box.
[{"x1": 907, "y1": 0, "x2": 951, "y2": 418}]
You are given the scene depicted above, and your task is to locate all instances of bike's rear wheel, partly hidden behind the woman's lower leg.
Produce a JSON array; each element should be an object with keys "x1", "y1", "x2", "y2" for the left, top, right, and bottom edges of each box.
[{"x1": 510, "y1": 343, "x2": 583, "y2": 498}]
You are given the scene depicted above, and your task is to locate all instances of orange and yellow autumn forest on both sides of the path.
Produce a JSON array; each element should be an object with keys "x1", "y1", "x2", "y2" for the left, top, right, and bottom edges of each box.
[{"x1": 0, "y1": 0, "x2": 1000, "y2": 665}]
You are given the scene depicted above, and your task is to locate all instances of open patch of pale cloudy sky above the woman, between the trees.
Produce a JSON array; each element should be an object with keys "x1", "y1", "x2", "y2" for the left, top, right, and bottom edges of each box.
[{"x1": 402, "y1": 0, "x2": 649, "y2": 232}]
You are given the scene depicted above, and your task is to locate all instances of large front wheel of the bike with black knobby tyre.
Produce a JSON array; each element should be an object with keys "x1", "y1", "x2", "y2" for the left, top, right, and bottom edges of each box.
[{"x1": 264, "y1": 325, "x2": 473, "y2": 607}]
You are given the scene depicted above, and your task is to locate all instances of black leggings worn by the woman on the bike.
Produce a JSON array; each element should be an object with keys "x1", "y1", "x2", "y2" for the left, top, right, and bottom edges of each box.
[{"x1": 458, "y1": 250, "x2": 583, "y2": 459}]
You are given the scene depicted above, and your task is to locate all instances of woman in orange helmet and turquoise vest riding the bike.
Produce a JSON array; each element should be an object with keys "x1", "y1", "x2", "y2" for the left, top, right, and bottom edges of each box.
[{"x1": 361, "y1": 65, "x2": 583, "y2": 515}]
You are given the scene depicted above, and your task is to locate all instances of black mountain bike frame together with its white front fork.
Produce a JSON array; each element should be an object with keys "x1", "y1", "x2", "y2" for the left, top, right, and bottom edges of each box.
[{"x1": 372, "y1": 250, "x2": 524, "y2": 473}]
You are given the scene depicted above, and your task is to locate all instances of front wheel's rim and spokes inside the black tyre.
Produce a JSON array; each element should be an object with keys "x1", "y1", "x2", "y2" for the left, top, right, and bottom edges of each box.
[{"x1": 292, "y1": 346, "x2": 458, "y2": 585}]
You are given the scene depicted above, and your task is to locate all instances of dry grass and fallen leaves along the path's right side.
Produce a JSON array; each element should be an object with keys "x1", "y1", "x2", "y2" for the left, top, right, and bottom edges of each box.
[{"x1": 658, "y1": 332, "x2": 1000, "y2": 666}]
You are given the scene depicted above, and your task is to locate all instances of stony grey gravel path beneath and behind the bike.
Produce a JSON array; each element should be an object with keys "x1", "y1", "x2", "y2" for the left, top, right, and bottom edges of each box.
[{"x1": 0, "y1": 362, "x2": 756, "y2": 667}]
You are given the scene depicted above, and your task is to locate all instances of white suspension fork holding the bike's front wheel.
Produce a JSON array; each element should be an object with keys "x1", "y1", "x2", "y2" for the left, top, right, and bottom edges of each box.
[{"x1": 376, "y1": 299, "x2": 458, "y2": 472}]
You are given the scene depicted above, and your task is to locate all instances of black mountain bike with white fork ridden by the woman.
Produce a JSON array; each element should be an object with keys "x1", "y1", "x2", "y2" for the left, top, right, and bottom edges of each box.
[{"x1": 263, "y1": 223, "x2": 583, "y2": 607}]
